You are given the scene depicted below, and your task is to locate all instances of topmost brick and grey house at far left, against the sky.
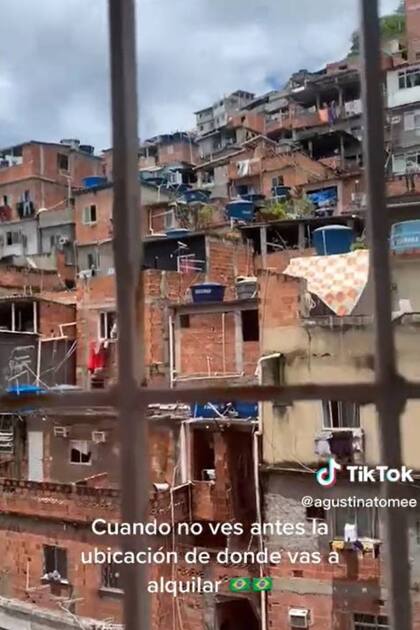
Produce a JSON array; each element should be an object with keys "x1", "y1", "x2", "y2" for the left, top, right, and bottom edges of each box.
[{"x1": 0, "y1": 140, "x2": 102, "y2": 275}]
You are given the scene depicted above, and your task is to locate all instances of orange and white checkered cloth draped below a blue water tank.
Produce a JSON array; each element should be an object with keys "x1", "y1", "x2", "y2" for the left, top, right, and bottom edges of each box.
[{"x1": 284, "y1": 249, "x2": 369, "y2": 317}]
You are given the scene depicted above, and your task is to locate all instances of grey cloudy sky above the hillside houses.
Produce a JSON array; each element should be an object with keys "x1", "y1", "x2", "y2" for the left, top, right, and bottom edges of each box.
[{"x1": 0, "y1": 0, "x2": 399, "y2": 151}]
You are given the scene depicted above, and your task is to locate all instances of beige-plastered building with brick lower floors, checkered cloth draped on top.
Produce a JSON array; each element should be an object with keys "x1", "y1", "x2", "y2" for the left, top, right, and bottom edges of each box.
[{"x1": 251, "y1": 239, "x2": 420, "y2": 630}]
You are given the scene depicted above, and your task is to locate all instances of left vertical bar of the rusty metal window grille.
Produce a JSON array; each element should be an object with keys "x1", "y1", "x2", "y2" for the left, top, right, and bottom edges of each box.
[{"x1": 109, "y1": 0, "x2": 149, "y2": 630}]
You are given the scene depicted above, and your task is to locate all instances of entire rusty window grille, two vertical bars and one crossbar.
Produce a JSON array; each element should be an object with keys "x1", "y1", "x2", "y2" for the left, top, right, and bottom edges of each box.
[{"x1": 0, "y1": 0, "x2": 414, "y2": 630}]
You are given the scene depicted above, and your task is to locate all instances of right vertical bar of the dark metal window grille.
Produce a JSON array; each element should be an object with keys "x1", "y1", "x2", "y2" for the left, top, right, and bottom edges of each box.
[{"x1": 360, "y1": 0, "x2": 411, "y2": 630}]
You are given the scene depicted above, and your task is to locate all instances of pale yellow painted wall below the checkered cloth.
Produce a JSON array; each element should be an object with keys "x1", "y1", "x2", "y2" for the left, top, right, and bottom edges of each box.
[{"x1": 263, "y1": 324, "x2": 420, "y2": 470}]
